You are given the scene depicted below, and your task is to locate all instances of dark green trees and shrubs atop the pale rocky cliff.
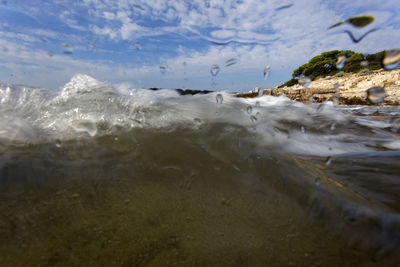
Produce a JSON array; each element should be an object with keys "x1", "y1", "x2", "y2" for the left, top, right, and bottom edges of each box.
[{"x1": 279, "y1": 50, "x2": 384, "y2": 87}]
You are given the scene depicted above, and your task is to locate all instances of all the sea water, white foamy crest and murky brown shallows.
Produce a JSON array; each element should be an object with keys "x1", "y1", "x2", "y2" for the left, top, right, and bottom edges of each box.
[{"x1": 0, "y1": 75, "x2": 400, "y2": 266}]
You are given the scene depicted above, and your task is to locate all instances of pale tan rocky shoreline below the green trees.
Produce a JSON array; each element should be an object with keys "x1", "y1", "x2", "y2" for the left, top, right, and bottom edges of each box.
[{"x1": 236, "y1": 69, "x2": 400, "y2": 105}]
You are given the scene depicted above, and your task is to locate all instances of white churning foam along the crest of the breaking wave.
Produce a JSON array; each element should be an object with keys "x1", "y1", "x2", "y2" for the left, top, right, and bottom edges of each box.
[{"x1": 0, "y1": 75, "x2": 394, "y2": 156}]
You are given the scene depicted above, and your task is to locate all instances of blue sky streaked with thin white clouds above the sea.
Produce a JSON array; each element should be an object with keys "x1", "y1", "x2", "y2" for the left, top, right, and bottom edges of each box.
[{"x1": 0, "y1": 0, "x2": 400, "y2": 92}]
